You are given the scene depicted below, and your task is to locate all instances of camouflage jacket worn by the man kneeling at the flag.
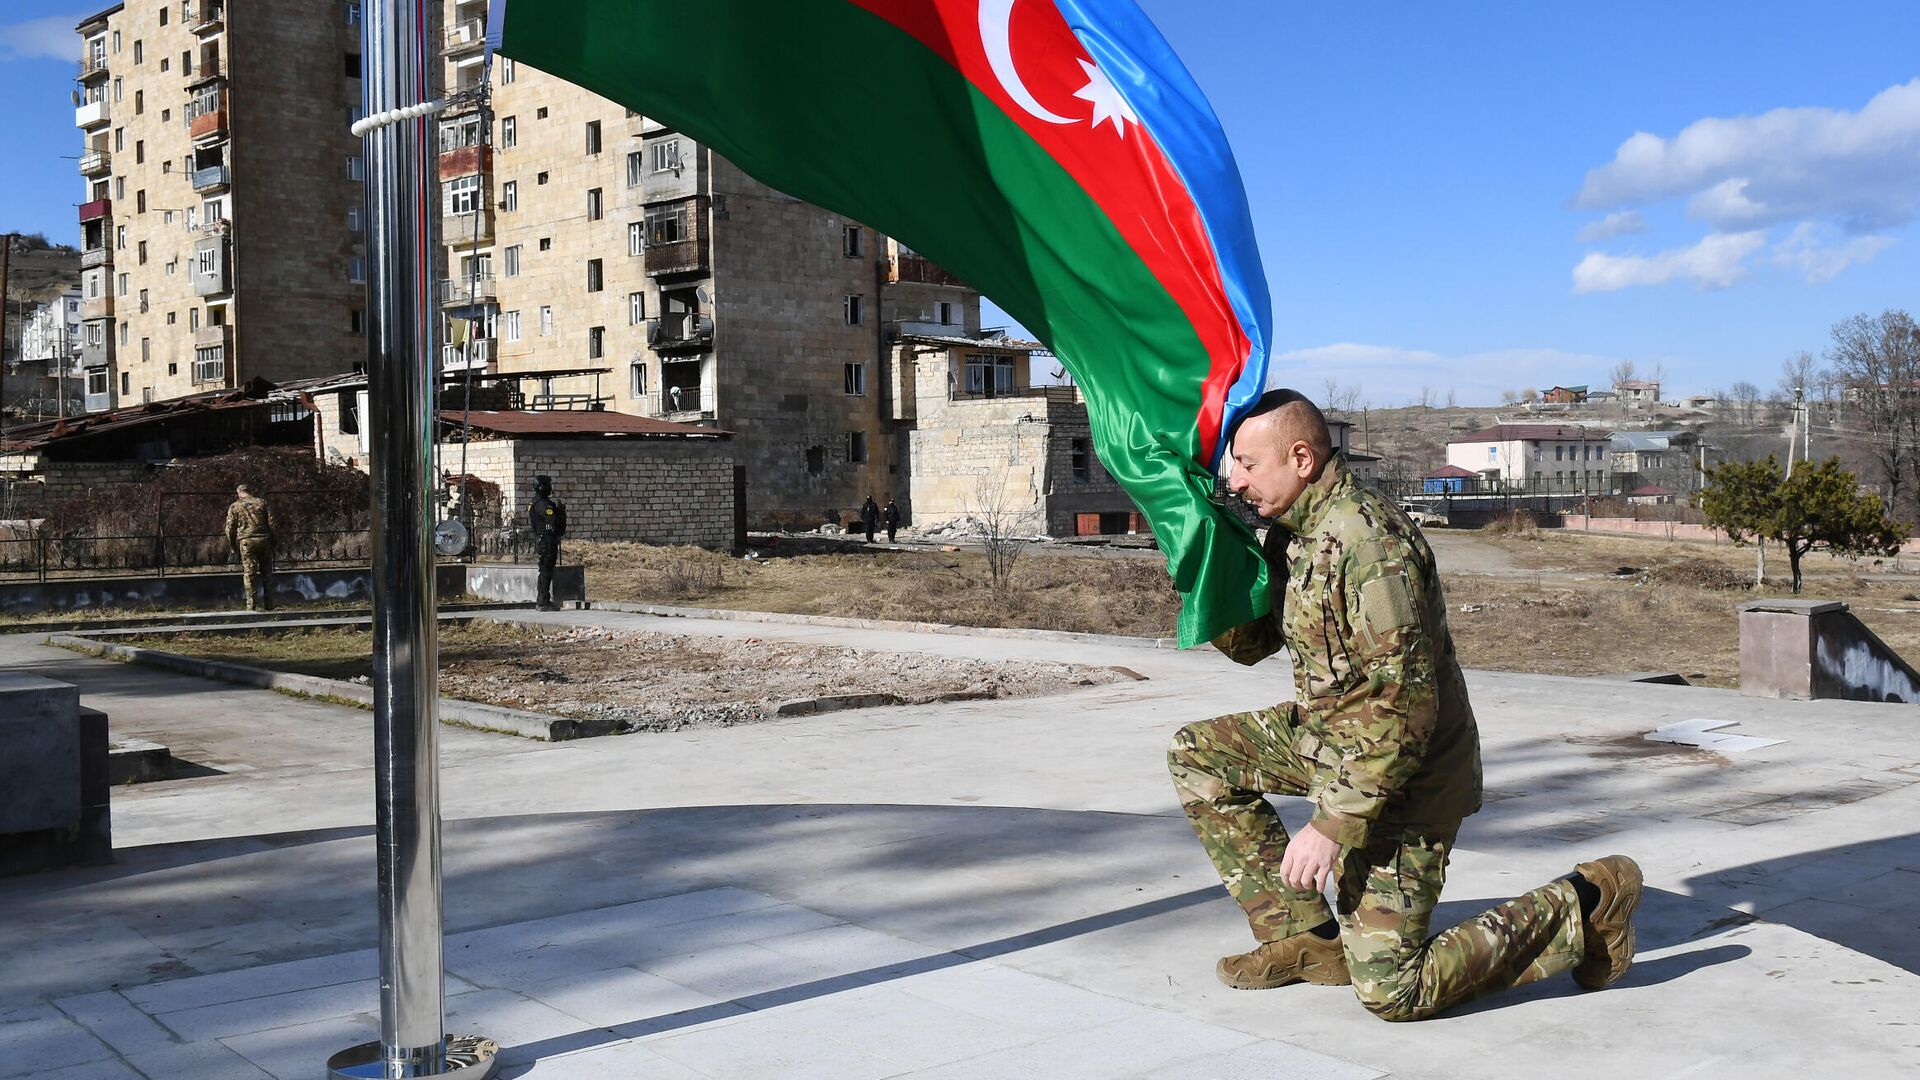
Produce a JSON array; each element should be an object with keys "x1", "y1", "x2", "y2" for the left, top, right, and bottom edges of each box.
[{"x1": 1213, "y1": 459, "x2": 1480, "y2": 847}]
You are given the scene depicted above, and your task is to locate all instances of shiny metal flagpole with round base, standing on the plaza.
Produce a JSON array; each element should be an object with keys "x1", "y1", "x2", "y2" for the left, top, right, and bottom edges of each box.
[{"x1": 326, "y1": 0, "x2": 497, "y2": 1080}]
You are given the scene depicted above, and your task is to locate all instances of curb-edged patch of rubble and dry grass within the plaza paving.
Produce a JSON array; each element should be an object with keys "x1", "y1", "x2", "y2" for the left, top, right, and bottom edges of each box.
[{"x1": 120, "y1": 621, "x2": 1133, "y2": 732}]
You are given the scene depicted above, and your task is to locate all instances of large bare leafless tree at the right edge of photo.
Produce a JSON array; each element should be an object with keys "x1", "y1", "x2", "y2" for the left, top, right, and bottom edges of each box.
[{"x1": 1826, "y1": 309, "x2": 1920, "y2": 515}]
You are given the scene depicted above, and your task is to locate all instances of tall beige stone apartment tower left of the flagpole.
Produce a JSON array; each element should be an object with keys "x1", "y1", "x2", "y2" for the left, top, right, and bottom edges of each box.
[{"x1": 77, "y1": 0, "x2": 367, "y2": 411}]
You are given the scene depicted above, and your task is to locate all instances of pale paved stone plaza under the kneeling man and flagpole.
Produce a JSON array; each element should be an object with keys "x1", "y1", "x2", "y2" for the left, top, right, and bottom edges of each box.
[{"x1": 0, "y1": 611, "x2": 1920, "y2": 1080}]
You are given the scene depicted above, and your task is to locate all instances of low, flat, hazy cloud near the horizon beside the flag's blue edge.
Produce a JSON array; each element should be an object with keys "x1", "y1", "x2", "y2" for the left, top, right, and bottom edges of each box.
[{"x1": 1267, "y1": 342, "x2": 1645, "y2": 407}]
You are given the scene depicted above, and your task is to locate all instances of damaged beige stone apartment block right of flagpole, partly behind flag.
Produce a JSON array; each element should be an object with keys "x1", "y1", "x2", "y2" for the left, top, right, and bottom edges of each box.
[{"x1": 440, "y1": 0, "x2": 979, "y2": 528}]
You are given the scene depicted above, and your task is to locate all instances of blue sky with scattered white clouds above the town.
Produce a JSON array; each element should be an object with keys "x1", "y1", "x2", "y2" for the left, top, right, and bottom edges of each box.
[{"x1": 0, "y1": 0, "x2": 1920, "y2": 405}]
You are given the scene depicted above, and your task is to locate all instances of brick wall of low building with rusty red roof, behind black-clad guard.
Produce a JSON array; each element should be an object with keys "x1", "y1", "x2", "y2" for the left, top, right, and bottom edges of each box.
[{"x1": 442, "y1": 438, "x2": 733, "y2": 550}]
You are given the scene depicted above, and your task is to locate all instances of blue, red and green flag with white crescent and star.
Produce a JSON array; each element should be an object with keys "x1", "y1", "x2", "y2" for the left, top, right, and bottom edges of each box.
[{"x1": 488, "y1": 0, "x2": 1273, "y2": 646}]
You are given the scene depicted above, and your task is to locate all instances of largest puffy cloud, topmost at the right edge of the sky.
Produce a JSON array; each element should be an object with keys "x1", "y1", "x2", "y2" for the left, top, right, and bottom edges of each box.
[{"x1": 1574, "y1": 79, "x2": 1920, "y2": 233}]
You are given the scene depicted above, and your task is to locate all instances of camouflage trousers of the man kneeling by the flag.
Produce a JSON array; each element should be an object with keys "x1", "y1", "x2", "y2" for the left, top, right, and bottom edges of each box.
[{"x1": 1167, "y1": 701, "x2": 1584, "y2": 1020}]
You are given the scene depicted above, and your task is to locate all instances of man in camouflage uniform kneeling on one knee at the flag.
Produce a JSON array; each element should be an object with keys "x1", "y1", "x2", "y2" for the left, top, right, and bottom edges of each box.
[{"x1": 1167, "y1": 390, "x2": 1642, "y2": 1020}]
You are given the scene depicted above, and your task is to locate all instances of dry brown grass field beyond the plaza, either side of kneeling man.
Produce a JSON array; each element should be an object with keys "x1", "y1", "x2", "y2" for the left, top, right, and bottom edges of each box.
[{"x1": 568, "y1": 528, "x2": 1920, "y2": 686}]
